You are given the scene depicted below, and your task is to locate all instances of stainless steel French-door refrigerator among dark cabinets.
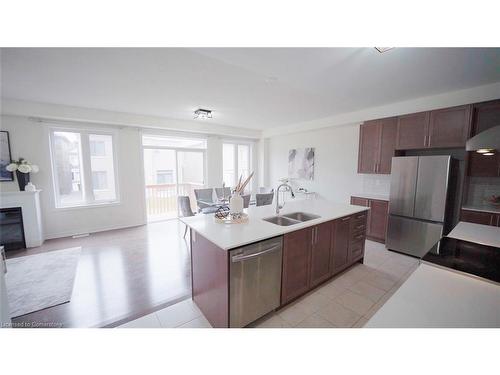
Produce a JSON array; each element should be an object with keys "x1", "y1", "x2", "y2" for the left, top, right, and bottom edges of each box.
[{"x1": 386, "y1": 155, "x2": 452, "y2": 258}]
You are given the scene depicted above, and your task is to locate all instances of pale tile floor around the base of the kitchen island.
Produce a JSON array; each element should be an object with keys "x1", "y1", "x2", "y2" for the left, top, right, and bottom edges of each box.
[{"x1": 119, "y1": 241, "x2": 418, "y2": 328}]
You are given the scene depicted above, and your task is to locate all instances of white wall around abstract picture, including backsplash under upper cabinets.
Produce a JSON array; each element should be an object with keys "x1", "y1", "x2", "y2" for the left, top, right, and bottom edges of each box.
[{"x1": 262, "y1": 124, "x2": 389, "y2": 203}]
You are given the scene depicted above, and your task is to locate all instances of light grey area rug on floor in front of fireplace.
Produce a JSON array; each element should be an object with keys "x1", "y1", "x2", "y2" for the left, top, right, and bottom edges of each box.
[{"x1": 5, "y1": 247, "x2": 82, "y2": 318}]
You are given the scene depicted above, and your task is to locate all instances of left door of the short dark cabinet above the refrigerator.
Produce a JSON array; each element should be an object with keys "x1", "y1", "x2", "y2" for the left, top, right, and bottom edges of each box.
[{"x1": 396, "y1": 112, "x2": 430, "y2": 150}]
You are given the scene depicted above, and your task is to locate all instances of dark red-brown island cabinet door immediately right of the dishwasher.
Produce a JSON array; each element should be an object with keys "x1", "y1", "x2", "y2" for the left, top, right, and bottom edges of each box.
[{"x1": 281, "y1": 228, "x2": 312, "y2": 304}]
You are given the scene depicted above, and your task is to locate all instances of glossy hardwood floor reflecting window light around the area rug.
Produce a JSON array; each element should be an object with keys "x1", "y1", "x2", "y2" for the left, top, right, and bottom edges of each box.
[{"x1": 8, "y1": 220, "x2": 191, "y2": 327}]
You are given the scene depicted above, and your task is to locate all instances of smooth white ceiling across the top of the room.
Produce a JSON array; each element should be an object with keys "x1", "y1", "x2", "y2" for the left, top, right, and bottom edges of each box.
[{"x1": 1, "y1": 48, "x2": 500, "y2": 129}]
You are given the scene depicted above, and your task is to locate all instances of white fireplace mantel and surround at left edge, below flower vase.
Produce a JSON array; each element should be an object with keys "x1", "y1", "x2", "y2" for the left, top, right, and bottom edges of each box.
[{"x1": 0, "y1": 190, "x2": 44, "y2": 247}]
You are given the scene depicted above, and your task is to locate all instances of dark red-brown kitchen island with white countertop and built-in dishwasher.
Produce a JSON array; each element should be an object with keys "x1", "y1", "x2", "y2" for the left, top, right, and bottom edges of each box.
[{"x1": 181, "y1": 199, "x2": 368, "y2": 327}]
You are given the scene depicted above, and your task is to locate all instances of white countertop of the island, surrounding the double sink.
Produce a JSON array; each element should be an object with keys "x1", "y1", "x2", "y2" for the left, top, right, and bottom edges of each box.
[{"x1": 180, "y1": 199, "x2": 368, "y2": 250}]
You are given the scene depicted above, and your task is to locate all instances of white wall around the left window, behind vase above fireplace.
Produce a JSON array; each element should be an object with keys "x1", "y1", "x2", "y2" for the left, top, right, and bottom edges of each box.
[{"x1": 0, "y1": 116, "x2": 145, "y2": 238}]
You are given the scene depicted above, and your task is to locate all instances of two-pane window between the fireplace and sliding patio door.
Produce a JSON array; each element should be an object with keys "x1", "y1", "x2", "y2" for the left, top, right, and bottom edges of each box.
[{"x1": 50, "y1": 129, "x2": 117, "y2": 207}]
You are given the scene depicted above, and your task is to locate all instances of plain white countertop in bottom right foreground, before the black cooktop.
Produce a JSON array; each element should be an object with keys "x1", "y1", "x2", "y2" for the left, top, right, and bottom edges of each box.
[{"x1": 365, "y1": 264, "x2": 500, "y2": 328}]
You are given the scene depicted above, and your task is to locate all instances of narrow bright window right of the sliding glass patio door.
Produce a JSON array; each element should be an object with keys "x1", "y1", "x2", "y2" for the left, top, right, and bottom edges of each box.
[{"x1": 222, "y1": 143, "x2": 251, "y2": 191}]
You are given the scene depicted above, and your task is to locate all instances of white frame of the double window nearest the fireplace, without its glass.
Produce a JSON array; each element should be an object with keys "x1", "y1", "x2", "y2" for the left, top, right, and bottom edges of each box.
[{"x1": 48, "y1": 125, "x2": 121, "y2": 210}]
